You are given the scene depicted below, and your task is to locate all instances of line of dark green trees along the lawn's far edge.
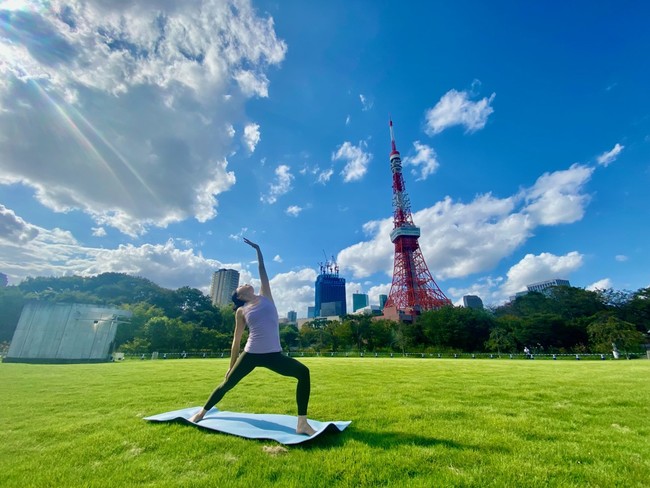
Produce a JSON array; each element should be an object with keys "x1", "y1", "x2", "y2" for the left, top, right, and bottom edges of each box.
[{"x1": 0, "y1": 273, "x2": 650, "y2": 354}]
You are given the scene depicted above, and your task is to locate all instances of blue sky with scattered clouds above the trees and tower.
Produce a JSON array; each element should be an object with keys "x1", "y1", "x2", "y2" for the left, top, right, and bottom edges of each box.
[{"x1": 0, "y1": 0, "x2": 650, "y2": 317}]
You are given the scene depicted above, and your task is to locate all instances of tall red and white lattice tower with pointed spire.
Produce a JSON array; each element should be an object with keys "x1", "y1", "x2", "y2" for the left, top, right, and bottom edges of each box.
[{"x1": 384, "y1": 120, "x2": 451, "y2": 318}]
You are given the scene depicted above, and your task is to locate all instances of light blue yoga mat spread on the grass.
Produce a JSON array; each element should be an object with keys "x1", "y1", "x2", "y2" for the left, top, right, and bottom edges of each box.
[{"x1": 144, "y1": 407, "x2": 352, "y2": 445}]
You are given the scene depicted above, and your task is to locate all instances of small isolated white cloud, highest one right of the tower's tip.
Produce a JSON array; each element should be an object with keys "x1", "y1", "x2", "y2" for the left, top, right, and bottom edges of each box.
[{"x1": 425, "y1": 90, "x2": 496, "y2": 135}]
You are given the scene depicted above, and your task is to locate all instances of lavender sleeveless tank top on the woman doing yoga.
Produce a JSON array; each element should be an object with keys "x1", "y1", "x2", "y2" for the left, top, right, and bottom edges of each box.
[{"x1": 244, "y1": 296, "x2": 282, "y2": 354}]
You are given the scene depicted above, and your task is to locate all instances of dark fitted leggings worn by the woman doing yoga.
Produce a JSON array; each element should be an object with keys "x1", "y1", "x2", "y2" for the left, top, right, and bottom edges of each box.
[{"x1": 203, "y1": 352, "x2": 311, "y2": 415}]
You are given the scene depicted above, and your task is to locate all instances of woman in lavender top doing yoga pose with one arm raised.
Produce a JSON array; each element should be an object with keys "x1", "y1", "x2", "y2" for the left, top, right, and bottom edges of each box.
[{"x1": 189, "y1": 238, "x2": 315, "y2": 436}]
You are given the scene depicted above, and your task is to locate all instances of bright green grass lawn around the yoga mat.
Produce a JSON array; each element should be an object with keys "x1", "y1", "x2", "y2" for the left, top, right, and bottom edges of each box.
[{"x1": 0, "y1": 358, "x2": 650, "y2": 488}]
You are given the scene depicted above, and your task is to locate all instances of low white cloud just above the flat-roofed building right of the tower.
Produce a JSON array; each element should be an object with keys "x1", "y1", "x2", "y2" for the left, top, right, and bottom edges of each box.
[{"x1": 502, "y1": 251, "x2": 583, "y2": 295}]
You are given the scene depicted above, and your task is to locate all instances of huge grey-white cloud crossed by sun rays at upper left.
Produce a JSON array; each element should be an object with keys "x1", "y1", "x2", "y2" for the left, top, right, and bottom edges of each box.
[{"x1": 0, "y1": 0, "x2": 287, "y2": 236}]
